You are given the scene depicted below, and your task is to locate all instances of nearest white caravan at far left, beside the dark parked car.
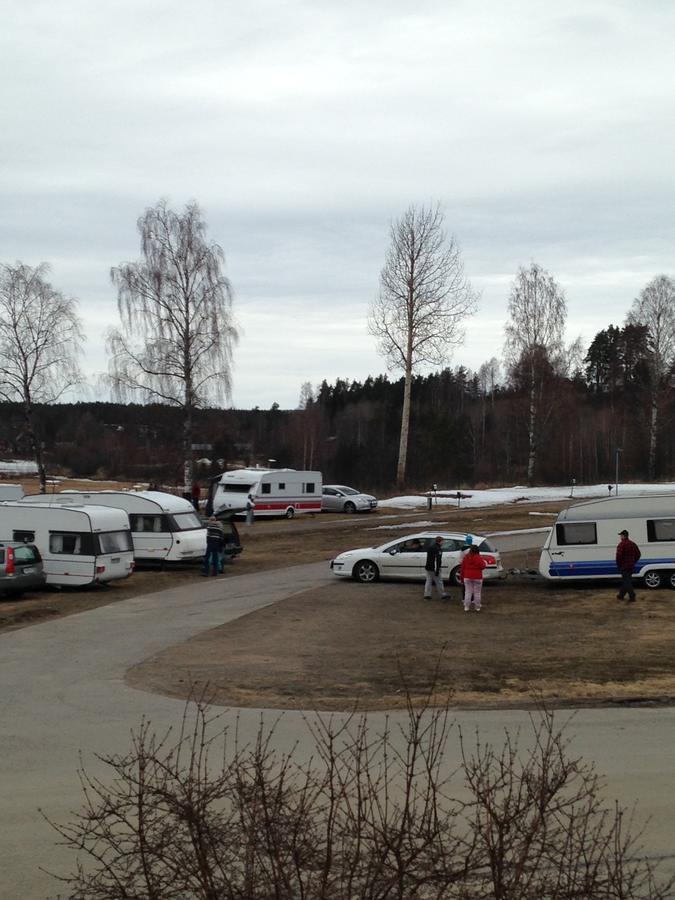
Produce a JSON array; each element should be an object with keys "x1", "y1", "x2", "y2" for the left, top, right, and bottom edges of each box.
[{"x1": 0, "y1": 501, "x2": 134, "y2": 587}]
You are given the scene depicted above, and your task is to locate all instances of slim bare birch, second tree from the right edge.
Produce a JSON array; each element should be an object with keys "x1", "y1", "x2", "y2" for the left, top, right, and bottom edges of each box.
[{"x1": 505, "y1": 263, "x2": 567, "y2": 484}]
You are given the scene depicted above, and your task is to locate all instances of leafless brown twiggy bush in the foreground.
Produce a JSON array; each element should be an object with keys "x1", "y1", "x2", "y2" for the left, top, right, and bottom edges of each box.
[{"x1": 46, "y1": 702, "x2": 670, "y2": 900}]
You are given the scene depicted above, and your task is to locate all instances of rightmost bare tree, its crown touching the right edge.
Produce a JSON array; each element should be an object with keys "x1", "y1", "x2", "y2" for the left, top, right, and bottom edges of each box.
[{"x1": 628, "y1": 275, "x2": 675, "y2": 478}]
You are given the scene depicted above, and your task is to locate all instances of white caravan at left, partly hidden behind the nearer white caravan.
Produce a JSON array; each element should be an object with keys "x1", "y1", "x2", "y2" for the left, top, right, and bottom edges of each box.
[{"x1": 22, "y1": 491, "x2": 206, "y2": 562}]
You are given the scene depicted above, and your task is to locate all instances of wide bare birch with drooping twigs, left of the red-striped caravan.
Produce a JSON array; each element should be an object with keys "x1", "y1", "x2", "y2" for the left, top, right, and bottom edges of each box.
[{"x1": 108, "y1": 200, "x2": 237, "y2": 491}]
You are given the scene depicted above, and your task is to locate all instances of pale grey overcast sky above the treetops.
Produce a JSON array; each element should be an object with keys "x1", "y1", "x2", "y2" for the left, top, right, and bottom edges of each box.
[{"x1": 0, "y1": 0, "x2": 675, "y2": 408}]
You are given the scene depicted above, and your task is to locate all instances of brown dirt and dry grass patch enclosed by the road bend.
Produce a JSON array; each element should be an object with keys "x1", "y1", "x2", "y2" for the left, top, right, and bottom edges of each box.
[{"x1": 128, "y1": 554, "x2": 675, "y2": 710}]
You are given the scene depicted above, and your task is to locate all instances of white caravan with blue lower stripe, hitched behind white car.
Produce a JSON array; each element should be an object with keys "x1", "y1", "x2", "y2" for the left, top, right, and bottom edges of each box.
[{"x1": 539, "y1": 493, "x2": 675, "y2": 588}]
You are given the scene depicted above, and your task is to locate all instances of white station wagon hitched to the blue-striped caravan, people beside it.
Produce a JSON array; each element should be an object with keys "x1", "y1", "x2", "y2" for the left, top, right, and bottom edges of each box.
[{"x1": 330, "y1": 531, "x2": 504, "y2": 584}]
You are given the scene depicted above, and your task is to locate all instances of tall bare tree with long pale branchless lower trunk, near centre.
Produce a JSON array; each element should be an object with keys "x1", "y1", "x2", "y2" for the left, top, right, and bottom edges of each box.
[{"x1": 368, "y1": 204, "x2": 478, "y2": 487}]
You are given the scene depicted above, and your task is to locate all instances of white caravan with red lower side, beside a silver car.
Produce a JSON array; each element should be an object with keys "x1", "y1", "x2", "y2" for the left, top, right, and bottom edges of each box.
[{"x1": 206, "y1": 469, "x2": 322, "y2": 519}]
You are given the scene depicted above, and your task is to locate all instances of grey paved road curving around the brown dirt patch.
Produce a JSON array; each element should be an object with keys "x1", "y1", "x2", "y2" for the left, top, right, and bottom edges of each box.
[{"x1": 0, "y1": 563, "x2": 675, "y2": 900}]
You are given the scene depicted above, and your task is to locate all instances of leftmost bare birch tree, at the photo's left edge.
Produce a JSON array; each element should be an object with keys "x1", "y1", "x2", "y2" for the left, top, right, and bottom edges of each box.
[{"x1": 0, "y1": 263, "x2": 83, "y2": 494}]
